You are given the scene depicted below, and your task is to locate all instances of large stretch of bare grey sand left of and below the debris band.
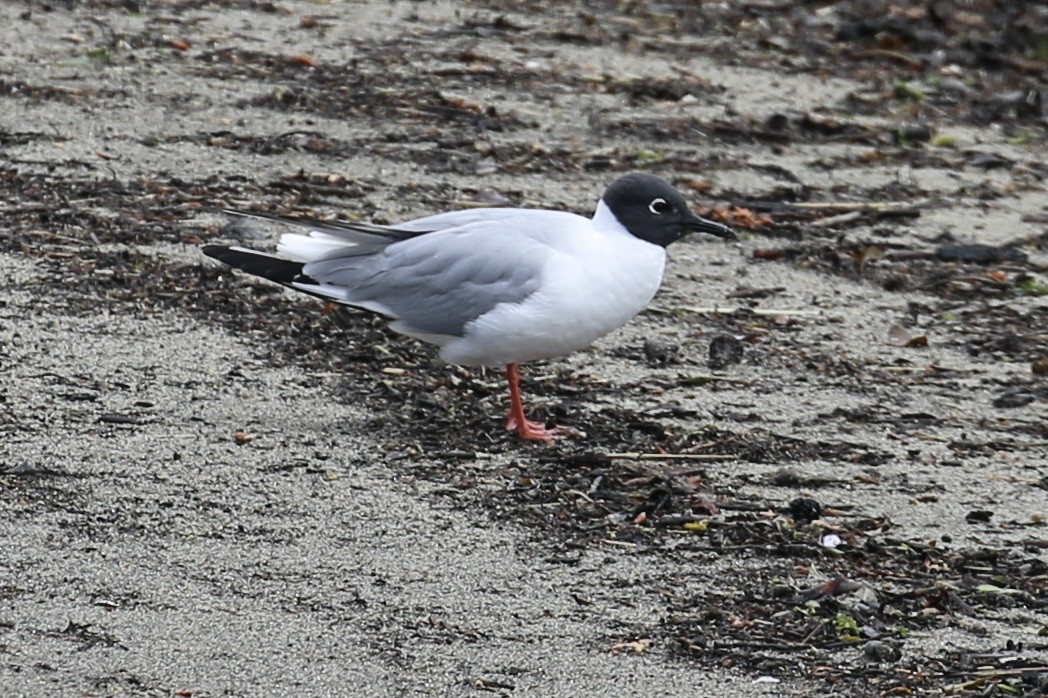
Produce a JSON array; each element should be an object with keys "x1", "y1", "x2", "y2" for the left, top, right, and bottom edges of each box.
[{"x1": 3, "y1": 250, "x2": 792, "y2": 695}]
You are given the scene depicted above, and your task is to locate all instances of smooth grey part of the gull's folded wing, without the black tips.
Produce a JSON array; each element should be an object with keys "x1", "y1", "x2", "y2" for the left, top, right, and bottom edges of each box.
[{"x1": 303, "y1": 222, "x2": 550, "y2": 336}]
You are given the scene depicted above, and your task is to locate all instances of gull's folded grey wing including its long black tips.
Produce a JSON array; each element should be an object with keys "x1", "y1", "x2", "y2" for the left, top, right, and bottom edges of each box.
[{"x1": 203, "y1": 209, "x2": 588, "y2": 343}]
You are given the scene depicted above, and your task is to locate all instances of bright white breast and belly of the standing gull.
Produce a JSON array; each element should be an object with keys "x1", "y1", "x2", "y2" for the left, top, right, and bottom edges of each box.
[{"x1": 440, "y1": 240, "x2": 665, "y2": 366}]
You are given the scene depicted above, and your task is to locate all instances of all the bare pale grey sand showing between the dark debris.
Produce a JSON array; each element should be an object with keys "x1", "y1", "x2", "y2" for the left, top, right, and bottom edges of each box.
[{"x1": 0, "y1": 1, "x2": 1048, "y2": 696}]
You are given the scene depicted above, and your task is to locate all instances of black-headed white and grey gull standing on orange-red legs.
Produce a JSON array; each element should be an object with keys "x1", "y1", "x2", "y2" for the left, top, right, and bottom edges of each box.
[{"x1": 203, "y1": 173, "x2": 735, "y2": 441}]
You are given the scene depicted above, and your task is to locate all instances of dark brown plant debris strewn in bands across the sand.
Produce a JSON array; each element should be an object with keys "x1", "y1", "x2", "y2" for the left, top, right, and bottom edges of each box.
[{"x1": 0, "y1": 1, "x2": 1048, "y2": 695}]
